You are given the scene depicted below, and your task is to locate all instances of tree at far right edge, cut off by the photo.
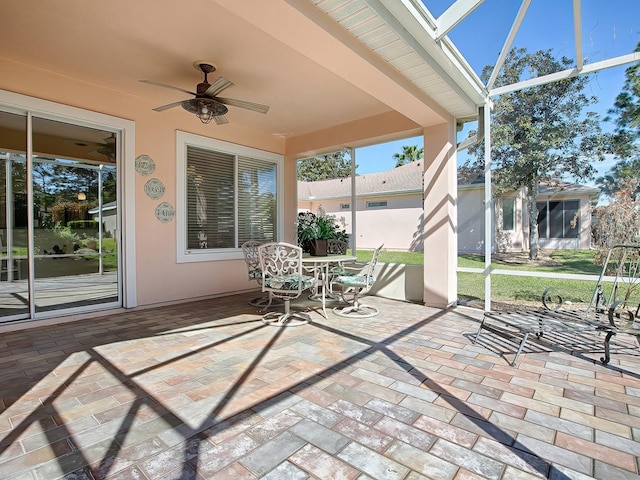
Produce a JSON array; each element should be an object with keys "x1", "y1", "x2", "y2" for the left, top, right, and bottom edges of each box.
[{"x1": 596, "y1": 43, "x2": 640, "y2": 199}]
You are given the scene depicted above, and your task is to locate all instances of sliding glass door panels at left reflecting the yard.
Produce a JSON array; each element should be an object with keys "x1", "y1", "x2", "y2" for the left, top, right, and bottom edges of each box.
[{"x1": 0, "y1": 112, "x2": 121, "y2": 321}]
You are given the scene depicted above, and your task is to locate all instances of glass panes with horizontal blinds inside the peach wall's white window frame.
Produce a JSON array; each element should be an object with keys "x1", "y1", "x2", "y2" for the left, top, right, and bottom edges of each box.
[{"x1": 186, "y1": 145, "x2": 277, "y2": 251}]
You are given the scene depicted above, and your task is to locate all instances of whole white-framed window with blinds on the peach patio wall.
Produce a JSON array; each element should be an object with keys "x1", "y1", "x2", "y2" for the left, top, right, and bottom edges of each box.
[{"x1": 176, "y1": 132, "x2": 281, "y2": 262}]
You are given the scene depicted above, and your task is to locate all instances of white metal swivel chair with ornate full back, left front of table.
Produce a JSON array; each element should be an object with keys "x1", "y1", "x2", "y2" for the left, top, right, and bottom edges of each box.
[{"x1": 258, "y1": 242, "x2": 315, "y2": 327}]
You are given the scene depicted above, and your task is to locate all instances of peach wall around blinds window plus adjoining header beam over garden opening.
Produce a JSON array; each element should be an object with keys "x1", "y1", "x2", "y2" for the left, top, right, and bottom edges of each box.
[{"x1": 0, "y1": 59, "x2": 430, "y2": 305}]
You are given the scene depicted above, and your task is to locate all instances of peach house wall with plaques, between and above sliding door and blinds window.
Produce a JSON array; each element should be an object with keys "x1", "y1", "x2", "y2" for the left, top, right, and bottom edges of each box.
[{"x1": 0, "y1": 59, "x2": 288, "y2": 305}]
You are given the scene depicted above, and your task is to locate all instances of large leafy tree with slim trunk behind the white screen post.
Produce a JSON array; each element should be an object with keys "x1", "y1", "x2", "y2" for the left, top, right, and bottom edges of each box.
[{"x1": 468, "y1": 48, "x2": 606, "y2": 260}]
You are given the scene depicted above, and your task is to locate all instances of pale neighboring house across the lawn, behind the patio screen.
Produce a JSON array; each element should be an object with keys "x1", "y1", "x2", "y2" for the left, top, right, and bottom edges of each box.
[{"x1": 298, "y1": 160, "x2": 600, "y2": 253}]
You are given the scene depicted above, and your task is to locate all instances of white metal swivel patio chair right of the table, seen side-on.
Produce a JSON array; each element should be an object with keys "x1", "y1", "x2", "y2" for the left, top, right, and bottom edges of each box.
[{"x1": 331, "y1": 245, "x2": 384, "y2": 318}]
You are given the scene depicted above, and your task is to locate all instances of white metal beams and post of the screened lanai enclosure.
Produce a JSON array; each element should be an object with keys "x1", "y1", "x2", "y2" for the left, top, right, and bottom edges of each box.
[{"x1": 431, "y1": 0, "x2": 640, "y2": 310}]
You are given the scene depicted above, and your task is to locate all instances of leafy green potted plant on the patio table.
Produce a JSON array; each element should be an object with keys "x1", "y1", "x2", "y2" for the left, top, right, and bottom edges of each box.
[{"x1": 297, "y1": 212, "x2": 347, "y2": 256}]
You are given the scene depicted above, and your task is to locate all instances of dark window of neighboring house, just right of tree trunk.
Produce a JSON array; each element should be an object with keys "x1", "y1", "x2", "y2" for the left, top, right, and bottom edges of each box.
[{"x1": 537, "y1": 200, "x2": 580, "y2": 238}]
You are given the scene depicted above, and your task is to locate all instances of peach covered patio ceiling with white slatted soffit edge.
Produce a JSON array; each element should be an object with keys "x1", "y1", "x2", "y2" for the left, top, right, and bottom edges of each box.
[{"x1": 0, "y1": 0, "x2": 484, "y2": 146}]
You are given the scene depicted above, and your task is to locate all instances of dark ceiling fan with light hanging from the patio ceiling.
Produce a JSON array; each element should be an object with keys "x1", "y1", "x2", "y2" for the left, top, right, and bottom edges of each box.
[{"x1": 139, "y1": 60, "x2": 269, "y2": 125}]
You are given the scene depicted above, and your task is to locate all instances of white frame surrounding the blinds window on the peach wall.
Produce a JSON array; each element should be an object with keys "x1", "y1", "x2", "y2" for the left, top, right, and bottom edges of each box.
[{"x1": 175, "y1": 130, "x2": 284, "y2": 263}]
